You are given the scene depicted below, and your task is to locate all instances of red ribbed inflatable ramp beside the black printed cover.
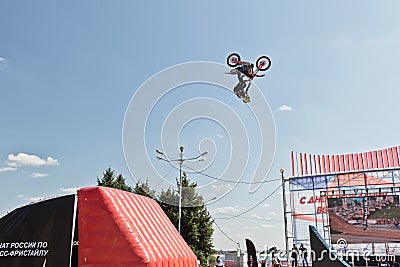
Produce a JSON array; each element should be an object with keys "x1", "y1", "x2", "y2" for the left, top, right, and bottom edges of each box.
[{"x1": 78, "y1": 187, "x2": 197, "y2": 267}]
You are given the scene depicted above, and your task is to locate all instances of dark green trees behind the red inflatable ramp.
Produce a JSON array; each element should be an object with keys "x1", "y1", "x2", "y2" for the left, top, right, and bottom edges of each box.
[{"x1": 97, "y1": 167, "x2": 214, "y2": 266}]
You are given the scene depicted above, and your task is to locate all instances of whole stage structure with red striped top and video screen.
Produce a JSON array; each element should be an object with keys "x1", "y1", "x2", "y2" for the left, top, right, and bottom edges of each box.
[{"x1": 282, "y1": 146, "x2": 400, "y2": 255}]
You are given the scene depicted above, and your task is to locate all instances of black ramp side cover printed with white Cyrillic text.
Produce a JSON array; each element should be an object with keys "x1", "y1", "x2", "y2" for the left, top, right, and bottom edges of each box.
[{"x1": 0, "y1": 195, "x2": 75, "y2": 267}]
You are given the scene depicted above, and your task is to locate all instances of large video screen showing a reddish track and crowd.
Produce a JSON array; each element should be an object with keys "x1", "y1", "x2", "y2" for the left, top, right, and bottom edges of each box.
[{"x1": 328, "y1": 195, "x2": 400, "y2": 243}]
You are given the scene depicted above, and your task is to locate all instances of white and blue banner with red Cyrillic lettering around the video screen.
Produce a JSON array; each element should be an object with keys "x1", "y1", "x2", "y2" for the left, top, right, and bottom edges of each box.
[{"x1": 289, "y1": 169, "x2": 400, "y2": 251}]
